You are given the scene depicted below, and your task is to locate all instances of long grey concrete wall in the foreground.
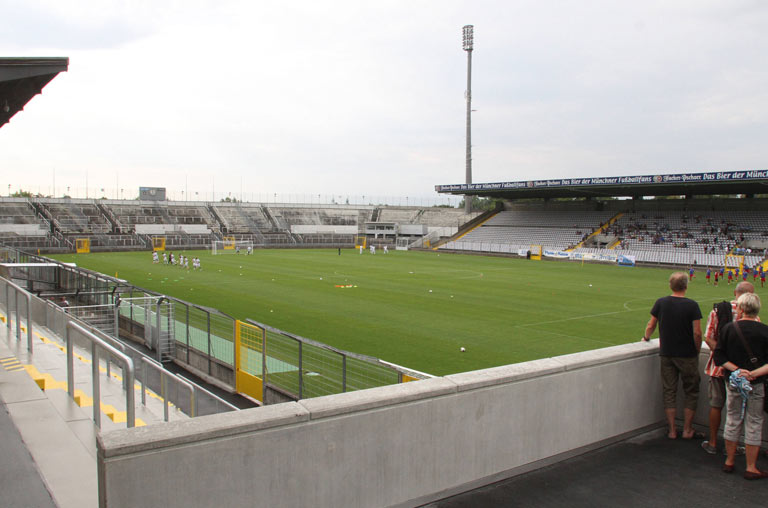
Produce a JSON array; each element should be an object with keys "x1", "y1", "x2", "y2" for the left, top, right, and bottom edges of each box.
[{"x1": 99, "y1": 343, "x2": 663, "y2": 507}]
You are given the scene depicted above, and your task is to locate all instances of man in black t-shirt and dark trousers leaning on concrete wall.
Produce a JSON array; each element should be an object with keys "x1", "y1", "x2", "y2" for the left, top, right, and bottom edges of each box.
[{"x1": 643, "y1": 272, "x2": 706, "y2": 439}]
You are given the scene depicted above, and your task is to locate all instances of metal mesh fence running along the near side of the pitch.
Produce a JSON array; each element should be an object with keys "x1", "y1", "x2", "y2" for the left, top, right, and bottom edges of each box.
[{"x1": 4, "y1": 249, "x2": 428, "y2": 404}]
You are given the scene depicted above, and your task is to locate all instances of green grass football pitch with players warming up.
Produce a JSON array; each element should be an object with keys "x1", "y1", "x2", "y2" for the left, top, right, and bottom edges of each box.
[{"x1": 51, "y1": 249, "x2": 764, "y2": 375}]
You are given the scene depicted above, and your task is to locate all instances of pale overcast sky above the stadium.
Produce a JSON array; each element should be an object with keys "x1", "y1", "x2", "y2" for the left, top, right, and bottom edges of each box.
[{"x1": 0, "y1": 0, "x2": 768, "y2": 201}]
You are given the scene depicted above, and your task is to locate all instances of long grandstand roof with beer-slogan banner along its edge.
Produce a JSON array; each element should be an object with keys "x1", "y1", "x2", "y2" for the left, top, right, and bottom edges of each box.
[{"x1": 435, "y1": 169, "x2": 768, "y2": 200}]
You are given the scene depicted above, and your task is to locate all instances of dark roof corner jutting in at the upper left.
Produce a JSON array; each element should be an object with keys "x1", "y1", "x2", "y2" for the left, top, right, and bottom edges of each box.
[{"x1": 0, "y1": 57, "x2": 69, "y2": 127}]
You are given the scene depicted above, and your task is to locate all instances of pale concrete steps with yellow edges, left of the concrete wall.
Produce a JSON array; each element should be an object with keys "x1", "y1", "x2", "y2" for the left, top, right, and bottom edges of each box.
[{"x1": 0, "y1": 313, "x2": 188, "y2": 508}]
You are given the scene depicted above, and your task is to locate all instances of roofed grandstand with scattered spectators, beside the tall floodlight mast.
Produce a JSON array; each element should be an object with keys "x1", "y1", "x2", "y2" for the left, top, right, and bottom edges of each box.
[{"x1": 436, "y1": 170, "x2": 768, "y2": 267}]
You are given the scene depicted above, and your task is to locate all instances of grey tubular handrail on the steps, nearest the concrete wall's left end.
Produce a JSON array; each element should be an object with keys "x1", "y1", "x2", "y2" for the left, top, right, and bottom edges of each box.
[{"x1": 66, "y1": 321, "x2": 136, "y2": 428}]
